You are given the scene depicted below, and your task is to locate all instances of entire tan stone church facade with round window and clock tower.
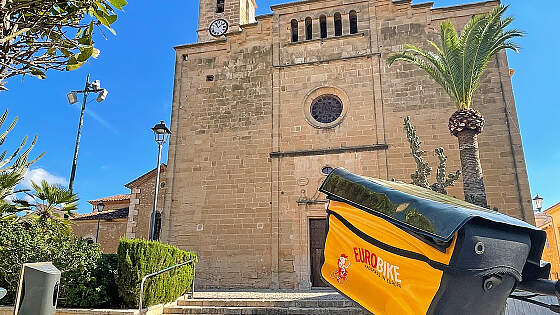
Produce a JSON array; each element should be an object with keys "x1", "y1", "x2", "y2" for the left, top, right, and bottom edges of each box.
[{"x1": 161, "y1": 0, "x2": 534, "y2": 289}]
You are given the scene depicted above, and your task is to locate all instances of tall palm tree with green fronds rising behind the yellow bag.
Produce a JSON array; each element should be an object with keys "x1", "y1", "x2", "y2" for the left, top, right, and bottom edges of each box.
[{"x1": 387, "y1": 6, "x2": 523, "y2": 207}]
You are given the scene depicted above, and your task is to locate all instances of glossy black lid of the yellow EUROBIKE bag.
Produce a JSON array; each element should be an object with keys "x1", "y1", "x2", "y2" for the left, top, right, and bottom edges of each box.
[{"x1": 319, "y1": 168, "x2": 546, "y2": 276}]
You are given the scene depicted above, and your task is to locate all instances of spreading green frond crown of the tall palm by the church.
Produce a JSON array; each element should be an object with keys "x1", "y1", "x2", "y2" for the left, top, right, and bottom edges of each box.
[{"x1": 387, "y1": 6, "x2": 523, "y2": 110}]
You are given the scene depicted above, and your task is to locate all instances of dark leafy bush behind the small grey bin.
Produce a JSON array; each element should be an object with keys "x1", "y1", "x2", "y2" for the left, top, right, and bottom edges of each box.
[{"x1": 0, "y1": 220, "x2": 120, "y2": 307}]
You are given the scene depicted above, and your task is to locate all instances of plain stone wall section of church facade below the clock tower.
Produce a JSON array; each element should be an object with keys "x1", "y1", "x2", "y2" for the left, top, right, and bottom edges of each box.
[{"x1": 162, "y1": 20, "x2": 272, "y2": 288}]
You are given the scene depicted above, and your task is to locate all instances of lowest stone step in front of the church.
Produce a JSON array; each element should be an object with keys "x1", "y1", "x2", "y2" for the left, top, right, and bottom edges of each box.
[{"x1": 164, "y1": 306, "x2": 371, "y2": 315}]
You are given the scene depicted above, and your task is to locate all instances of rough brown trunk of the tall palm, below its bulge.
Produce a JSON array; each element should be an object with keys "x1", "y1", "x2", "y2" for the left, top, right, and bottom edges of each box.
[{"x1": 457, "y1": 129, "x2": 488, "y2": 208}]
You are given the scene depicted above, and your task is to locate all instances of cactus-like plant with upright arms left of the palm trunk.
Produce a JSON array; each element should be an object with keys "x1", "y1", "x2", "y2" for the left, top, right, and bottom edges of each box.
[{"x1": 404, "y1": 116, "x2": 461, "y2": 195}]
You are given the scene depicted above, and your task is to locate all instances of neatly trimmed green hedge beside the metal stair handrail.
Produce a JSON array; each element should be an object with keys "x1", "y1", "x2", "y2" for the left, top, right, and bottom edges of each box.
[{"x1": 117, "y1": 238, "x2": 197, "y2": 308}]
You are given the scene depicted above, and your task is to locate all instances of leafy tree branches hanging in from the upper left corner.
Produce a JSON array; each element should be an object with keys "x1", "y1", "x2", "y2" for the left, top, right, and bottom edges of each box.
[{"x1": 0, "y1": 0, "x2": 127, "y2": 90}]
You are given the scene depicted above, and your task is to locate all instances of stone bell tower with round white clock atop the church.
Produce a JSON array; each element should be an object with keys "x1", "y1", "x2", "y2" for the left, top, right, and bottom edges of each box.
[{"x1": 197, "y1": 0, "x2": 257, "y2": 43}]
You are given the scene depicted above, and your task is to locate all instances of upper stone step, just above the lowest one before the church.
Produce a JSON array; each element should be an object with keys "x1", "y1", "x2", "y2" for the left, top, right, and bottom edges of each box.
[{"x1": 177, "y1": 299, "x2": 357, "y2": 308}]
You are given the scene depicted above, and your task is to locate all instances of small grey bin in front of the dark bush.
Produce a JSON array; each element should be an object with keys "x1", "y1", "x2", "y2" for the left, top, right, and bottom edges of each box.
[{"x1": 15, "y1": 263, "x2": 60, "y2": 315}]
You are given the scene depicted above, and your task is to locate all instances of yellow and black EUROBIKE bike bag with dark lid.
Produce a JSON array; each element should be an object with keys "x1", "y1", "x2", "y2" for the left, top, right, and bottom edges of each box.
[{"x1": 320, "y1": 168, "x2": 550, "y2": 315}]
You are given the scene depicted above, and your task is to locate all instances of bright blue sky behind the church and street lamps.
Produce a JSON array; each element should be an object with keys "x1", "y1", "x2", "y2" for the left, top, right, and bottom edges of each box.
[{"x1": 0, "y1": 0, "x2": 560, "y2": 212}]
